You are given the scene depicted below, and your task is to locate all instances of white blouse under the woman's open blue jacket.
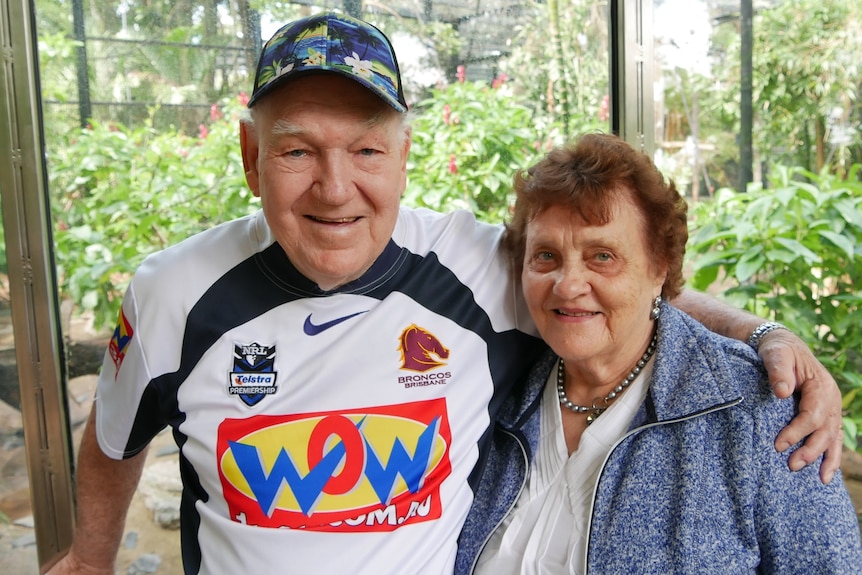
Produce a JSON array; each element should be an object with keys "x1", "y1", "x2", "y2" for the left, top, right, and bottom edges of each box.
[{"x1": 475, "y1": 360, "x2": 653, "y2": 575}]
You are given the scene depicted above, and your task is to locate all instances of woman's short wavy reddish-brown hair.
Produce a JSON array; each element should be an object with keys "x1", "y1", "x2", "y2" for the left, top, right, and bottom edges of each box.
[{"x1": 503, "y1": 133, "x2": 688, "y2": 298}]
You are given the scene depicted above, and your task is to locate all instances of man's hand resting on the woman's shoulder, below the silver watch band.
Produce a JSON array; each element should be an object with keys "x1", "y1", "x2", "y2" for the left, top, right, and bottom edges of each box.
[{"x1": 758, "y1": 329, "x2": 844, "y2": 483}]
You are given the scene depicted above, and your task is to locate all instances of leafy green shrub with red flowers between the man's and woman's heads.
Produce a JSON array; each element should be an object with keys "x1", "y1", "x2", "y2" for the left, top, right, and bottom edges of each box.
[{"x1": 404, "y1": 82, "x2": 560, "y2": 222}]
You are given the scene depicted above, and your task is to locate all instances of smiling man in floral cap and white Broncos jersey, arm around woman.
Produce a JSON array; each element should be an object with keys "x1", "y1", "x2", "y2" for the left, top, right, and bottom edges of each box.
[{"x1": 51, "y1": 10, "x2": 839, "y2": 574}]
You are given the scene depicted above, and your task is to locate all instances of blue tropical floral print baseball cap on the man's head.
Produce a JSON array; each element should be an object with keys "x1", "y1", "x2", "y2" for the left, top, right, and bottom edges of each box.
[{"x1": 248, "y1": 12, "x2": 407, "y2": 112}]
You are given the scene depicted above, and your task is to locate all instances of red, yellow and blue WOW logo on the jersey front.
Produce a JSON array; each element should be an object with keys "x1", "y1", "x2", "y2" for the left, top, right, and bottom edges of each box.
[{"x1": 217, "y1": 399, "x2": 452, "y2": 531}]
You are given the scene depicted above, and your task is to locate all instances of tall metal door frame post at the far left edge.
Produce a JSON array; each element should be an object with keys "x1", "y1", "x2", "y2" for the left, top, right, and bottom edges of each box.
[{"x1": 0, "y1": 0, "x2": 73, "y2": 567}]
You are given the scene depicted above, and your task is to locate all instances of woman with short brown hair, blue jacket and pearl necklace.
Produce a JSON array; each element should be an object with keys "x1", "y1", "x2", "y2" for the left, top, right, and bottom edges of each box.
[{"x1": 458, "y1": 134, "x2": 862, "y2": 575}]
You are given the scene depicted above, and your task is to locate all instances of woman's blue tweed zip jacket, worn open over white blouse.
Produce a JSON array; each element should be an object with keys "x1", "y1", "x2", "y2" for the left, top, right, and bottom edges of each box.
[{"x1": 455, "y1": 305, "x2": 862, "y2": 575}]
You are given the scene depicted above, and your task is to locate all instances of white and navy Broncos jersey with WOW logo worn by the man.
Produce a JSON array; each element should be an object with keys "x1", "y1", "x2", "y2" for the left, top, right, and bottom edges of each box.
[{"x1": 97, "y1": 209, "x2": 543, "y2": 574}]
